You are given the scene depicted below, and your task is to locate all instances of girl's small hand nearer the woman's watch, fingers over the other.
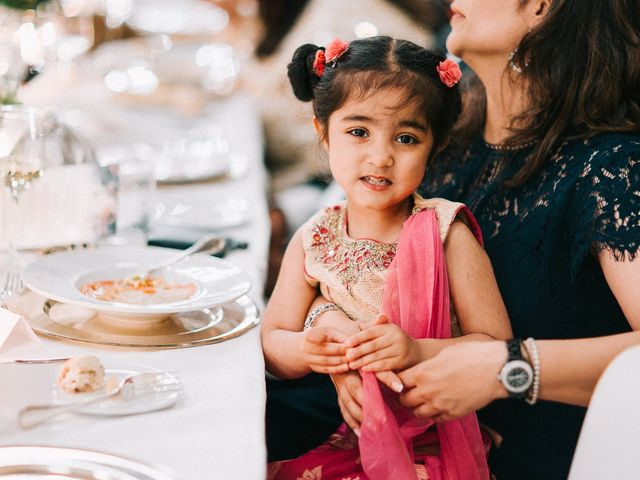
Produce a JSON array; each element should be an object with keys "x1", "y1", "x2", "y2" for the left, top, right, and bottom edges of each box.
[{"x1": 345, "y1": 314, "x2": 421, "y2": 372}]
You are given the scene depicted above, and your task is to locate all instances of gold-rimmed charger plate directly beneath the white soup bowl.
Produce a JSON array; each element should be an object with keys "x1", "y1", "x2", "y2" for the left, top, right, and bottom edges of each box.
[{"x1": 7, "y1": 292, "x2": 260, "y2": 348}]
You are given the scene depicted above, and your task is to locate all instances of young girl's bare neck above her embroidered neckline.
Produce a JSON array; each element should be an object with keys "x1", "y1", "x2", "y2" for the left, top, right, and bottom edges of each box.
[{"x1": 347, "y1": 201, "x2": 413, "y2": 243}]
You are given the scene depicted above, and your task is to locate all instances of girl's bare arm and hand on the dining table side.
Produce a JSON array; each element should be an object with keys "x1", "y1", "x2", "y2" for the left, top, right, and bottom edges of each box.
[{"x1": 261, "y1": 232, "x2": 348, "y2": 378}]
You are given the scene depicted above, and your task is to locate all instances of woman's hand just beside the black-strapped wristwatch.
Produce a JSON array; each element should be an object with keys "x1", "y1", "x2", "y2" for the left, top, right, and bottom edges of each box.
[{"x1": 399, "y1": 341, "x2": 507, "y2": 421}]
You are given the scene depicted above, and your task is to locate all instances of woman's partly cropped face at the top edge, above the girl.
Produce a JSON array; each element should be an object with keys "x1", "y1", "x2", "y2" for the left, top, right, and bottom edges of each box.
[{"x1": 447, "y1": 0, "x2": 539, "y2": 68}]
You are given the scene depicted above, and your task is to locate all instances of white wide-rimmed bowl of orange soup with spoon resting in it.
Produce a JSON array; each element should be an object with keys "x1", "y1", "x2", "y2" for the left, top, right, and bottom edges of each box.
[{"x1": 22, "y1": 247, "x2": 251, "y2": 321}]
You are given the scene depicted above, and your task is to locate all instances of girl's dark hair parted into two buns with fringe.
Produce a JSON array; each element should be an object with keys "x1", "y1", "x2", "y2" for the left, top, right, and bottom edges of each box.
[{"x1": 289, "y1": 36, "x2": 461, "y2": 156}]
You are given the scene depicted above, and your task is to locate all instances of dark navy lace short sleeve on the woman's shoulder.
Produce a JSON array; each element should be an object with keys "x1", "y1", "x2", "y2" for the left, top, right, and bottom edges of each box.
[{"x1": 568, "y1": 140, "x2": 640, "y2": 273}]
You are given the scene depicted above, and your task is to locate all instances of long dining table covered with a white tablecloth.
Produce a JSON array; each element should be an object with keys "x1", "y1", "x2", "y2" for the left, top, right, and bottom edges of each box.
[{"x1": 0, "y1": 40, "x2": 270, "y2": 480}]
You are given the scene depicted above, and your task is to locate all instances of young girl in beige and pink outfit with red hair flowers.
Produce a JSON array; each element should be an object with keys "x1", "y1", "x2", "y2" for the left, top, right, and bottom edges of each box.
[{"x1": 262, "y1": 37, "x2": 511, "y2": 480}]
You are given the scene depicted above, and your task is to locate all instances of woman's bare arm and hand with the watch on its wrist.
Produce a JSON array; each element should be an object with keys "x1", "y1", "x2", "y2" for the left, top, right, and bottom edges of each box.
[{"x1": 400, "y1": 250, "x2": 640, "y2": 419}]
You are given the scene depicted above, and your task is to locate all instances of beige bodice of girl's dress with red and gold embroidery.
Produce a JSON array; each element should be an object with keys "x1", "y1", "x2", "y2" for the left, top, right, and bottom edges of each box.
[{"x1": 302, "y1": 193, "x2": 466, "y2": 324}]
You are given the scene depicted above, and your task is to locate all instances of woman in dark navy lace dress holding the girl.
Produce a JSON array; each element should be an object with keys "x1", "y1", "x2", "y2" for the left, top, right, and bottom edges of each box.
[{"x1": 318, "y1": 0, "x2": 640, "y2": 480}]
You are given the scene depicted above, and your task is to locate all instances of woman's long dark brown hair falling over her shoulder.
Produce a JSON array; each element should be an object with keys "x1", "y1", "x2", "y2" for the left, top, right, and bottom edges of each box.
[{"x1": 456, "y1": 0, "x2": 640, "y2": 186}]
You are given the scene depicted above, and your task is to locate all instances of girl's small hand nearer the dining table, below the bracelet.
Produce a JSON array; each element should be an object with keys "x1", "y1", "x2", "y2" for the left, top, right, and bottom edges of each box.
[{"x1": 300, "y1": 327, "x2": 349, "y2": 373}]
